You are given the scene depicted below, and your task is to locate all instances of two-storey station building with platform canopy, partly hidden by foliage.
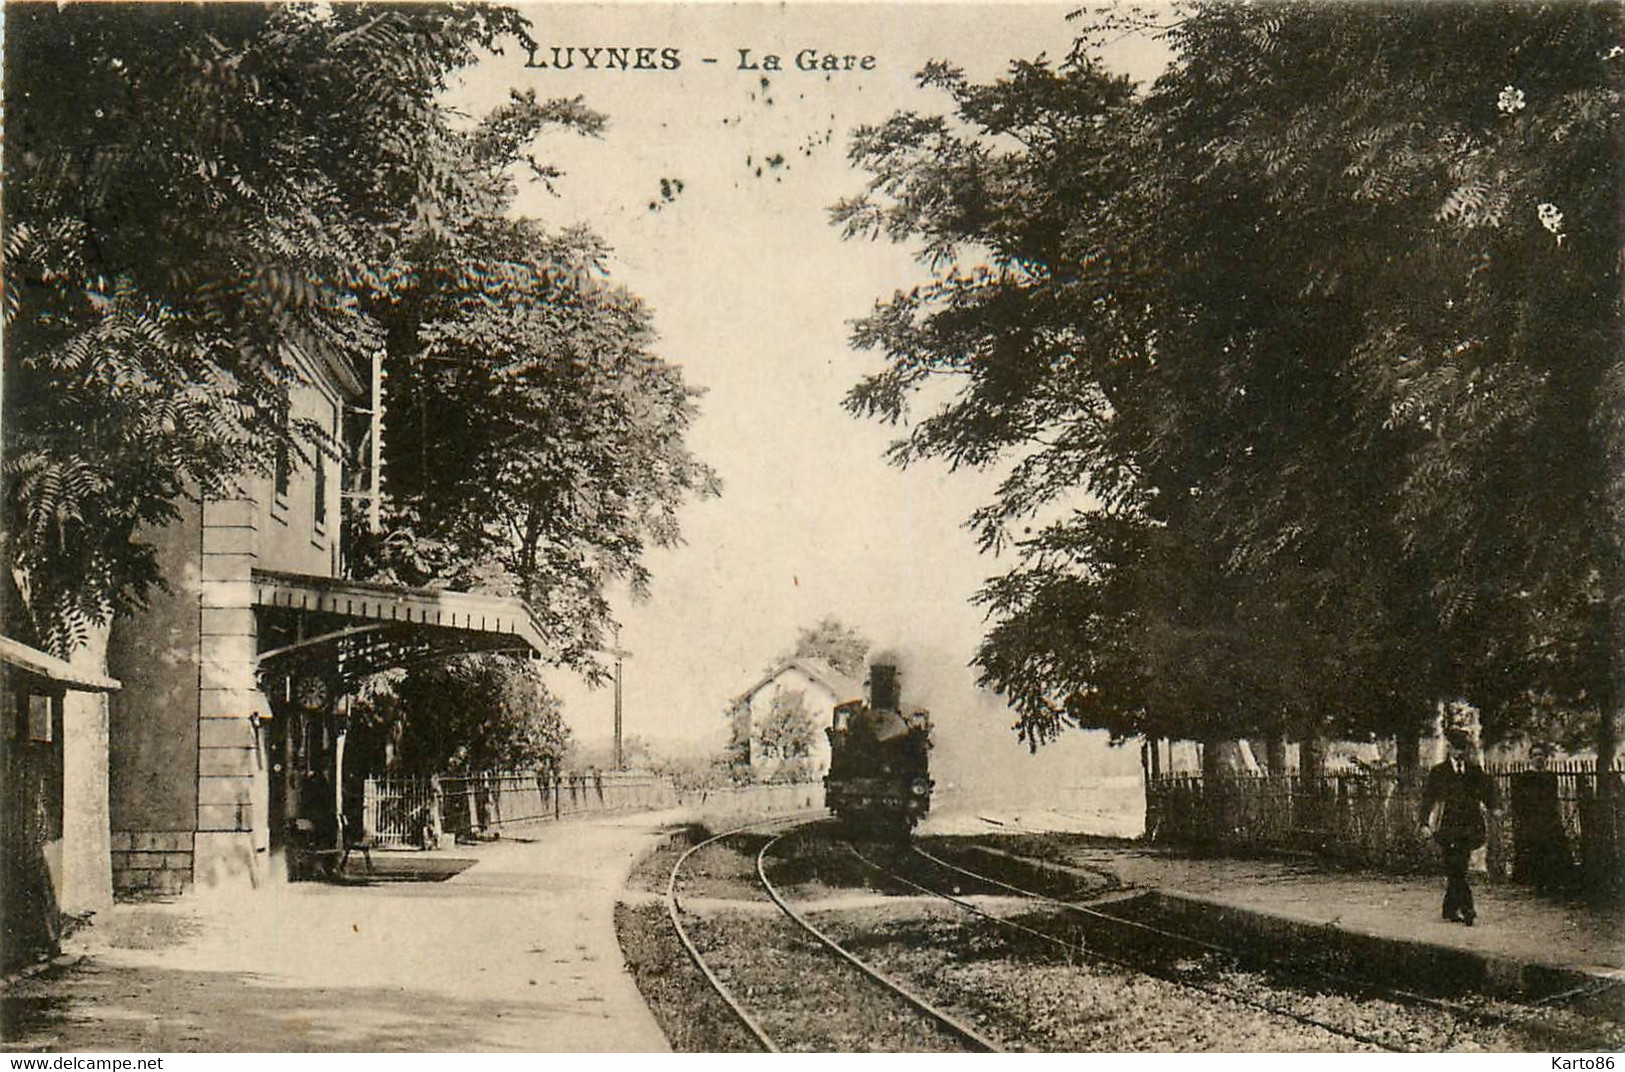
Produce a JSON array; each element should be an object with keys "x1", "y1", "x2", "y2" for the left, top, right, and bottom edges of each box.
[{"x1": 107, "y1": 351, "x2": 543, "y2": 893}]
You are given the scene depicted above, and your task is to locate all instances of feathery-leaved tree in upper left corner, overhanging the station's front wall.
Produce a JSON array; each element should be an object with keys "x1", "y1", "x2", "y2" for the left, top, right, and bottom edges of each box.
[{"x1": 3, "y1": 5, "x2": 523, "y2": 653}]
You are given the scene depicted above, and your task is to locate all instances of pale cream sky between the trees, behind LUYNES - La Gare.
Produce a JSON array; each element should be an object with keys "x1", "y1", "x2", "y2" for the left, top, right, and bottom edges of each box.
[{"x1": 450, "y1": 3, "x2": 1164, "y2": 783}]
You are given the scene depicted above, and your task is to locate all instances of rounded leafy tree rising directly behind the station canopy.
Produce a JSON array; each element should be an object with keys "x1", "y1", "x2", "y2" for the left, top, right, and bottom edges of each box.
[{"x1": 362, "y1": 219, "x2": 720, "y2": 672}]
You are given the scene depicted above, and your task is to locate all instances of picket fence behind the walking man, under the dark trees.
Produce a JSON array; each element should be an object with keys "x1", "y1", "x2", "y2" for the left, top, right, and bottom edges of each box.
[{"x1": 1146, "y1": 760, "x2": 1625, "y2": 893}]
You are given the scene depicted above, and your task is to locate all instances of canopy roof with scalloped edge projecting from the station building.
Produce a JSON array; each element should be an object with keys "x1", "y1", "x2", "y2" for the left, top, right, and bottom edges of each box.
[{"x1": 254, "y1": 570, "x2": 548, "y2": 682}]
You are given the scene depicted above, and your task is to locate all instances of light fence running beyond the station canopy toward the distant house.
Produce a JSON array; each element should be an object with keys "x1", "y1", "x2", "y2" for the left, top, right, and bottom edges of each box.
[{"x1": 361, "y1": 772, "x2": 678, "y2": 848}]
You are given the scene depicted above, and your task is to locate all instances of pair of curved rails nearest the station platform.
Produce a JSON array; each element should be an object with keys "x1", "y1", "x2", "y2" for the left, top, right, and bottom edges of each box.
[{"x1": 666, "y1": 819, "x2": 999, "y2": 1053}]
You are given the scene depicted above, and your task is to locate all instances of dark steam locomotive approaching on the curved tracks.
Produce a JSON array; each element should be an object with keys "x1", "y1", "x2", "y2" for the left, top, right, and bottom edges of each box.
[{"x1": 824, "y1": 663, "x2": 934, "y2": 836}]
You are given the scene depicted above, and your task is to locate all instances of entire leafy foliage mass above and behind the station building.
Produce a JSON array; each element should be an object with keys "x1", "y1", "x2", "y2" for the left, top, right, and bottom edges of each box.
[{"x1": 3, "y1": 3, "x2": 715, "y2": 685}]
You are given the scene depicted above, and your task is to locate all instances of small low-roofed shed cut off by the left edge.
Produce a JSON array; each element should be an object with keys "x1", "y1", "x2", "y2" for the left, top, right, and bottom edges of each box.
[{"x1": 0, "y1": 637, "x2": 119, "y2": 968}]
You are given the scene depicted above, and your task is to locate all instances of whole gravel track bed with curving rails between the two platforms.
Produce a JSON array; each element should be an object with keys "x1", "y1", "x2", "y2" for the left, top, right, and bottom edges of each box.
[{"x1": 650, "y1": 819, "x2": 1620, "y2": 1053}]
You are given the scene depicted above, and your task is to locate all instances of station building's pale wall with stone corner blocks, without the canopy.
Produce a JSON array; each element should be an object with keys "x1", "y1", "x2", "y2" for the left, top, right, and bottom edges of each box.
[{"x1": 109, "y1": 357, "x2": 351, "y2": 893}]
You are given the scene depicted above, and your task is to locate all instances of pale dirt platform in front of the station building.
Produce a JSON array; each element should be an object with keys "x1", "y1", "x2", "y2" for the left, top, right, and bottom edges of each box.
[{"x1": 0, "y1": 814, "x2": 685, "y2": 1053}]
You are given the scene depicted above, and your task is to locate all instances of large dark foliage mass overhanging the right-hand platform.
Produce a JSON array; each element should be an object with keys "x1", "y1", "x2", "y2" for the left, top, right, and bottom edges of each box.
[{"x1": 835, "y1": 3, "x2": 1625, "y2": 744}]
